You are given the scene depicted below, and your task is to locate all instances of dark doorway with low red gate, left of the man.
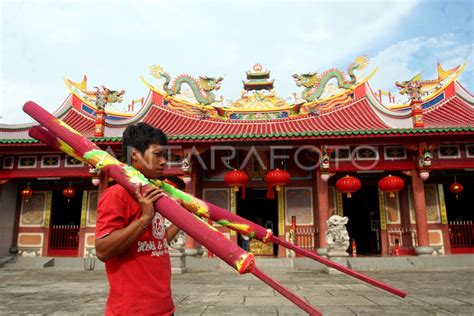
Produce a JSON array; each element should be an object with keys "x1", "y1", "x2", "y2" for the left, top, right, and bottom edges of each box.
[{"x1": 48, "y1": 190, "x2": 83, "y2": 257}]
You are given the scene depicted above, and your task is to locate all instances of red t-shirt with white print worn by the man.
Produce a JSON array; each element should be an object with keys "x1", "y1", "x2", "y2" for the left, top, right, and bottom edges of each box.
[{"x1": 95, "y1": 185, "x2": 175, "y2": 315}]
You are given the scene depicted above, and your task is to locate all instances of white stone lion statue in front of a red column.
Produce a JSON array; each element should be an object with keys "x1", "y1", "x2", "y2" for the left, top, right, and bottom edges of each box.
[{"x1": 326, "y1": 215, "x2": 350, "y2": 256}]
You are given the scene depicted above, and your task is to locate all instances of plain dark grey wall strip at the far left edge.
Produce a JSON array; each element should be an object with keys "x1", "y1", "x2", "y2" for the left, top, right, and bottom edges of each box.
[{"x1": 0, "y1": 183, "x2": 18, "y2": 257}]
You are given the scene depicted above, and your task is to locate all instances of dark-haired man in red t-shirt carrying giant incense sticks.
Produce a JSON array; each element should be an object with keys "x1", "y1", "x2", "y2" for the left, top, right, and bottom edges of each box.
[{"x1": 95, "y1": 123, "x2": 179, "y2": 315}]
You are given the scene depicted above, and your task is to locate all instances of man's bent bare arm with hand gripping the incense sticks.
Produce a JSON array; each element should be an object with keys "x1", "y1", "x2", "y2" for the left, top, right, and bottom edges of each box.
[{"x1": 95, "y1": 186, "x2": 164, "y2": 262}]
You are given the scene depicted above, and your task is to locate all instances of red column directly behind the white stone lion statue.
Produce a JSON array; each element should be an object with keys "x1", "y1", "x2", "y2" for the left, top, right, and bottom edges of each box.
[{"x1": 316, "y1": 169, "x2": 329, "y2": 255}]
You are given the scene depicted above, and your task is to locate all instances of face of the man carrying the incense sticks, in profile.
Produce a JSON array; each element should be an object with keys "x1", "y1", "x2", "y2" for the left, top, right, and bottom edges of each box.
[{"x1": 132, "y1": 144, "x2": 168, "y2": 179}]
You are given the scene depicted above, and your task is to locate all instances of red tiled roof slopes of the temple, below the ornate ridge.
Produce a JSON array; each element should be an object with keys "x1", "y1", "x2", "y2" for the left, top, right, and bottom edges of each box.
[{"x1": 0, "y1": 82, "x2": 474, "y2": 144}]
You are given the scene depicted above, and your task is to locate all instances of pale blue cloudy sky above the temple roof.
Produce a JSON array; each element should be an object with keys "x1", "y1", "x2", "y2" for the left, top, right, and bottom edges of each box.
[{"x1": 0, "y1": 0, "x2": 474, "y2": 124}]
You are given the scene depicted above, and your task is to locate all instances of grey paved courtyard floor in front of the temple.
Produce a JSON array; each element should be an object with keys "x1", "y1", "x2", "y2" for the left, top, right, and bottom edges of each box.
[{"x1": 0, "y1": 268, "x2": 474, "y2": 315}]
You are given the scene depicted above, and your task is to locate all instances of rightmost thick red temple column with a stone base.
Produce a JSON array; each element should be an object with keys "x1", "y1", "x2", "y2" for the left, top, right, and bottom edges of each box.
[{"x1": 411, "y1": 169, "x2": 434, "y2": 256}]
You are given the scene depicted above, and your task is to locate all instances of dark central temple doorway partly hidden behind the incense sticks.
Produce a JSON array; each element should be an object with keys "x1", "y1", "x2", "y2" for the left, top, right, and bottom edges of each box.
[{"x1": 237, "y1": 188, "x2": 278, "y2": 256}]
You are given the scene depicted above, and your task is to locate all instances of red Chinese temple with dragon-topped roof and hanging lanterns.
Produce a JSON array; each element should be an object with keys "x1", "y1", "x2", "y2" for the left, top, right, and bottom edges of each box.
[{"x1": 0, "y1": 57, "x2": 474, "y2": 257}]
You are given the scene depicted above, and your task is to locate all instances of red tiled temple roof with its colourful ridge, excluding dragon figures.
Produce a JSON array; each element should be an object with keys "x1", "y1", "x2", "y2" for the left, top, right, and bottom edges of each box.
[{"x1": 0, "y1": 60, "x2": 474, "y2": 145}]
